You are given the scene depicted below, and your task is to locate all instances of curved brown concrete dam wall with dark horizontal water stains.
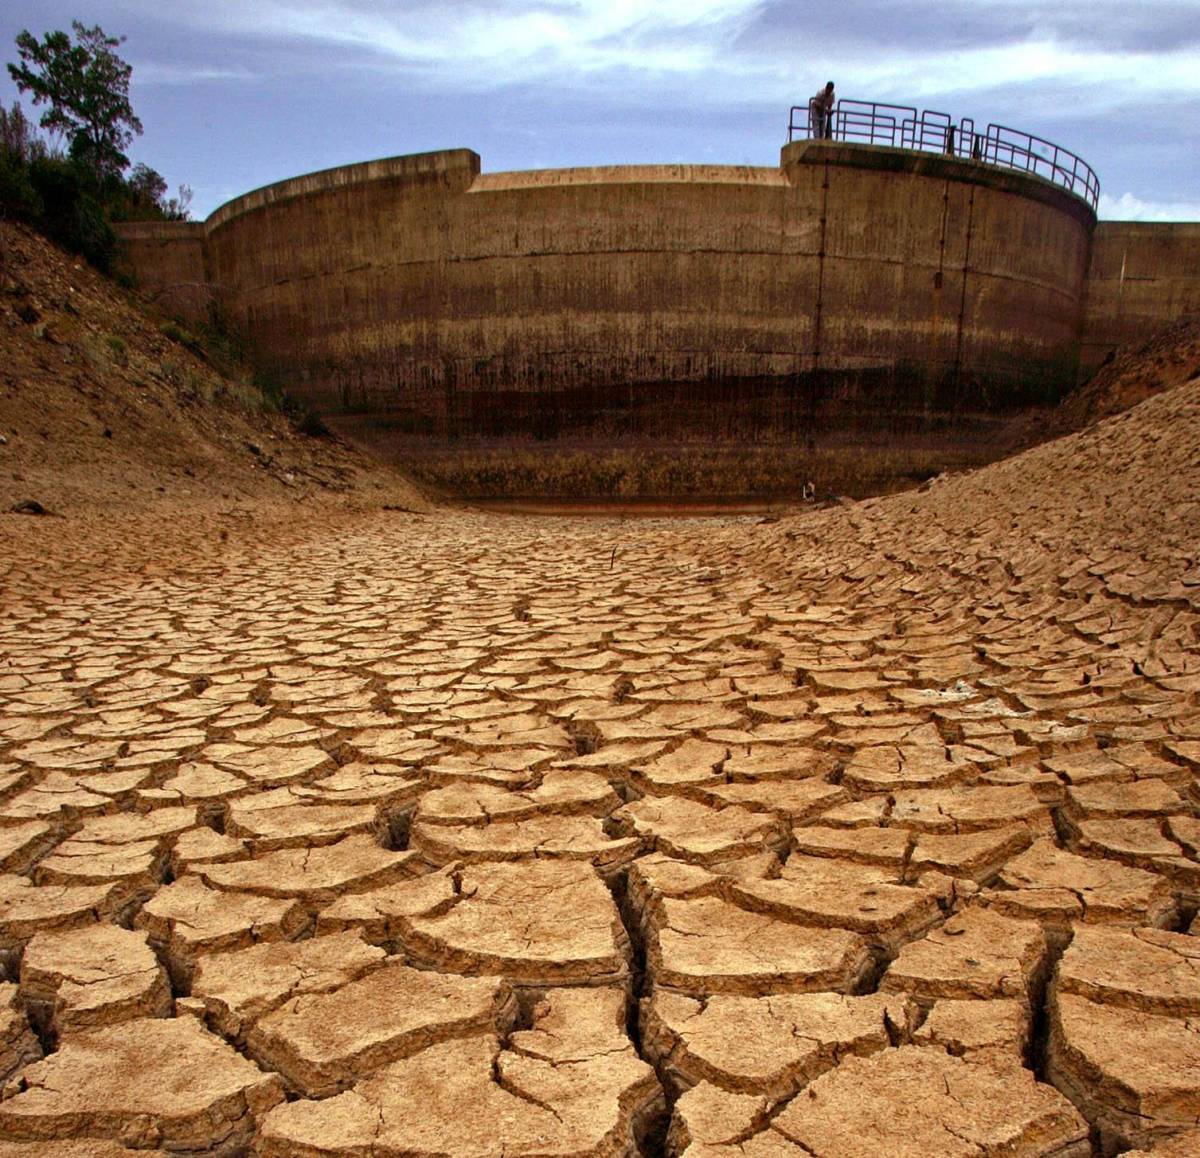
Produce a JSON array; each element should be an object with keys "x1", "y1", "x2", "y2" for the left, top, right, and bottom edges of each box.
[{"x1": 110, "y1": 140, "x2": 1200, "y2": 451}]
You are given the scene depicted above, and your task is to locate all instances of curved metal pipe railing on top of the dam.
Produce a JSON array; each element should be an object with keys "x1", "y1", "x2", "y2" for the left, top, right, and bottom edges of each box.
[{"x1": 787, "y1": 101, "x2": 1100, "y2": 210}]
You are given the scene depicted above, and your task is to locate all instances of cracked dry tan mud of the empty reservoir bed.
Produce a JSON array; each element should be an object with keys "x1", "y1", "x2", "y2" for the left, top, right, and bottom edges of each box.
[{"x1": 0, "y1": 384, "x2": 1200, "y2": 1158}]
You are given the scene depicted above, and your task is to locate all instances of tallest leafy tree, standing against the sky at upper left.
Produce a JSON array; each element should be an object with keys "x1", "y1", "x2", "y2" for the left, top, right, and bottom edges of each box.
[{"x1": 8, "y1": 20, "x2": 142, "y2": 187}]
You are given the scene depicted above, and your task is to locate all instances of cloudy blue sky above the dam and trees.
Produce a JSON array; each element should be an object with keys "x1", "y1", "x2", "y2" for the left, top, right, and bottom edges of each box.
[{"x1": 0, "y1": 0, "x2": 1200, "y2": 220}]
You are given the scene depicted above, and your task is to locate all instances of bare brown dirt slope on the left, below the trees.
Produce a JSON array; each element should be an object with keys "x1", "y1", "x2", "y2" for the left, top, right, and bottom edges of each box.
[{"x1": 0, "y1": 222, "x2": 424, "y2": 515}]
